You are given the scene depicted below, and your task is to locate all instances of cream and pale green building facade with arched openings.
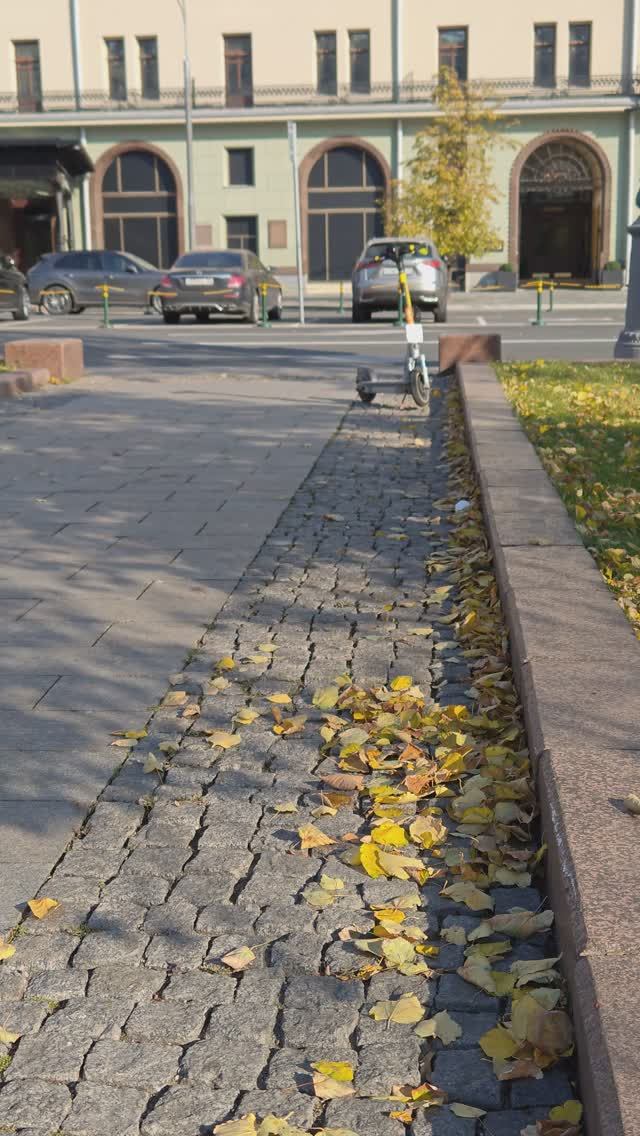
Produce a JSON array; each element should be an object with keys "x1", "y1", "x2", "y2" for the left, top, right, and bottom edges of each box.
[{"x1": 0, "y1": 0, "x2": 640, "y2": 282}]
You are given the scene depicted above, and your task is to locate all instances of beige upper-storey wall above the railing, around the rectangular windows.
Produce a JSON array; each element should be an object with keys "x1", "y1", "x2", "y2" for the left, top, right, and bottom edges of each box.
[{"x1": 0, "y1": 0, "x2": 629, "y2": 91}]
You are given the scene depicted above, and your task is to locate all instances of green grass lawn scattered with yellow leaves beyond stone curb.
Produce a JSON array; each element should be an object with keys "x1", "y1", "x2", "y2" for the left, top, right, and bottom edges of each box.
[{"x1": 498, "y1": 360, "x2": 640, "y2": 638}]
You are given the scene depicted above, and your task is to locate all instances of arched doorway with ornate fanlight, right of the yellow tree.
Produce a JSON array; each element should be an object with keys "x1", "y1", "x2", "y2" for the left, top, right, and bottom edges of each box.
[{"x1": 517, "y1": 136, "x2": 605, "y2": 281}]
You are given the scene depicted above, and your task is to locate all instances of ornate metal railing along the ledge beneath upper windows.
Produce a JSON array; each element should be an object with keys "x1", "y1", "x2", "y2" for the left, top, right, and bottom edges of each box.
[{"x1": 0, "y1": 75, "x2": 640, "y2": 116}]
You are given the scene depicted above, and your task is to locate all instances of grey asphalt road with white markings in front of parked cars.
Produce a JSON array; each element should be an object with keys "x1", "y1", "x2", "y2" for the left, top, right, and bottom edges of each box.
[{"x1": 0, "y1": 292, "x2": 625, "y2": 377}]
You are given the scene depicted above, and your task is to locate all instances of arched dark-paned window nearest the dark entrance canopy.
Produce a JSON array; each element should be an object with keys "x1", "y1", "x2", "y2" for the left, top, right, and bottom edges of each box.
[{"x1": 97, "y1": 147, "x2": 180, "y2": 268}]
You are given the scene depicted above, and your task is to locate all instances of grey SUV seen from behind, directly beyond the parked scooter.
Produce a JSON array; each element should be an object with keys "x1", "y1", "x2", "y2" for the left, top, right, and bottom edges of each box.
[{"x1": 351, "y1": 236, "x2": 449, "y2": 324}]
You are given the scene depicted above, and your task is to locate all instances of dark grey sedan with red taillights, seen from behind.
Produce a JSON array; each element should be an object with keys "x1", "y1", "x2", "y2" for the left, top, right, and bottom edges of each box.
[{"x1": 158, "y1": 249, "x2": 282, "y2": 324}]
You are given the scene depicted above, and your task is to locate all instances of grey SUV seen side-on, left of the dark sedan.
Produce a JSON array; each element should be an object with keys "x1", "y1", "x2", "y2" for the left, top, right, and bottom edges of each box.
[{"x1": 26, "y1": 249, "x2": 163, "y2": 316}]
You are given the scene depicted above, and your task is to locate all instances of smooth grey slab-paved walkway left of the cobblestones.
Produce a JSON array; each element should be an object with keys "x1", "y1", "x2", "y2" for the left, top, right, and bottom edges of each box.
[{"x1": 0, "y1": 372, "x2": 350, "y2": 932}]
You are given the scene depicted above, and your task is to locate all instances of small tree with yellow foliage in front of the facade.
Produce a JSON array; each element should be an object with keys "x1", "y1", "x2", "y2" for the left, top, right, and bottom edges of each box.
[{"x1": 385, "y1": 67, "x2": 506, "y2": 263}]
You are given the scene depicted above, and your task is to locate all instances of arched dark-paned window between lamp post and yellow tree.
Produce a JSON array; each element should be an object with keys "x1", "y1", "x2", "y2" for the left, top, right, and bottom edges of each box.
[{"x1": 301, "y1": 140, "x2": 388, "y2": 281}]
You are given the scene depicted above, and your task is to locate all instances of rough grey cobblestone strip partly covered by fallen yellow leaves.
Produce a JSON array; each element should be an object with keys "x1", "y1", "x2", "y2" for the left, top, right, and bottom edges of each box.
[{"x1": 0, "y1": 383, "x2": 572, "y2": 1136}]
